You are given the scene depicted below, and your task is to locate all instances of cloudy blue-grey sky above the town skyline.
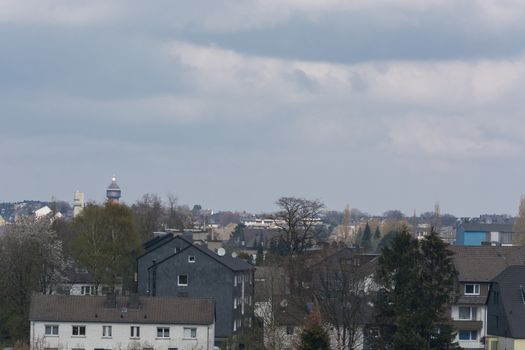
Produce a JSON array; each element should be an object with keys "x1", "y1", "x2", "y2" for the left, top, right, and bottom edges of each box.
[{"x1": 0, "y1": 0, "x2": 525, "y2": 216}]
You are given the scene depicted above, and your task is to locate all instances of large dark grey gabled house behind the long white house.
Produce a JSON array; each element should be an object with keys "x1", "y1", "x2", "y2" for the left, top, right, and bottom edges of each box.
[{"x1": 137, "y1": 234, "x2": 255, "y2": 342}]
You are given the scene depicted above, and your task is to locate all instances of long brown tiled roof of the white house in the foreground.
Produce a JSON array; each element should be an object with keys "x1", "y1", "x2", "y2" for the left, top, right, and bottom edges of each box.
[{"x1": 29, "y1": 294, "x2": 215, "y2": 324}]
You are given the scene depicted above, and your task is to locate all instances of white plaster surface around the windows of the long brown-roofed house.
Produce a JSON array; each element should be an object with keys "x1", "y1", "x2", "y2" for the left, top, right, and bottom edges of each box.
[{"x1": 31, "y1": 322, "x2": 215, "y2": 350}]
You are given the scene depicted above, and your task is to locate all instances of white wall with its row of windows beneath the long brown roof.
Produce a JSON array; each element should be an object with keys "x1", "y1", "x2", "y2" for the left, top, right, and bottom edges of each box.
[{"x1": 31, "y1": 321, "x2": 214, "y2": 350}]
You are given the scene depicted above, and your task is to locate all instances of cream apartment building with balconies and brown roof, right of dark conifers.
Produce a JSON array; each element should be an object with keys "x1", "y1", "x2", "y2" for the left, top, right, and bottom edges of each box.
[{"x1": 449, "y1": 246, "x2": 525, "y2": 349}]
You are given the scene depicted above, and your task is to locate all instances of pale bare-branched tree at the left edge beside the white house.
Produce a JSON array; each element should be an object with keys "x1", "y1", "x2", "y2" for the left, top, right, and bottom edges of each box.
[{"x1": 0, "y1": 217, "x2": 66, "y2": 340}]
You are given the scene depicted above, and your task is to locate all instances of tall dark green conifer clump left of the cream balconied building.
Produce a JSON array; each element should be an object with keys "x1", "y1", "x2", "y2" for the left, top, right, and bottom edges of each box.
[{"x1": 375, "y1": 227, "x2": 457, "y2": 350}]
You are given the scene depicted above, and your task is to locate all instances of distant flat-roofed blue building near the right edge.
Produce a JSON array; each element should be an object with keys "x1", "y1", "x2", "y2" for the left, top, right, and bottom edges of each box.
[{"x1": 455, "y1": 222, "x2": 513, "y2": 246}]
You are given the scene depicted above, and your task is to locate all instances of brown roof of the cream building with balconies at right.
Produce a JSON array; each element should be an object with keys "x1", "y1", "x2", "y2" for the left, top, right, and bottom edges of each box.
[{"x1": 449, "y1": 246, "x2": 525, "y2": 282}]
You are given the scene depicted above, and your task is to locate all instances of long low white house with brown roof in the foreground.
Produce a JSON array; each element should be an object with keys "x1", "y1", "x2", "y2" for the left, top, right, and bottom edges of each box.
[{"x1": 29, "y1": 295, "x2": 215, "y2": 350}]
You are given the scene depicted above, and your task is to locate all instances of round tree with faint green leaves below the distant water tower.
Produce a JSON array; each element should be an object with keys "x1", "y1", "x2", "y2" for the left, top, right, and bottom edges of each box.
[{"x1": 73, "y1": 203, "x2": 141, "y2": 288}]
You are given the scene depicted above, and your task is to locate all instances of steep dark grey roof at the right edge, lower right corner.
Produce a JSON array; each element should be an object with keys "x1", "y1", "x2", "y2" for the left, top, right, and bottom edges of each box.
[{"x1": 494, "y1": 265, "x2": 525, "y2": 339}]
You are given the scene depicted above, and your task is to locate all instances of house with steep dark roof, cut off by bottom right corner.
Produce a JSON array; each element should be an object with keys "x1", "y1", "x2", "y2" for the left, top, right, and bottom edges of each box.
[{"x1": 486, "y1": 264, "x2": 525, "y2": 350}]
